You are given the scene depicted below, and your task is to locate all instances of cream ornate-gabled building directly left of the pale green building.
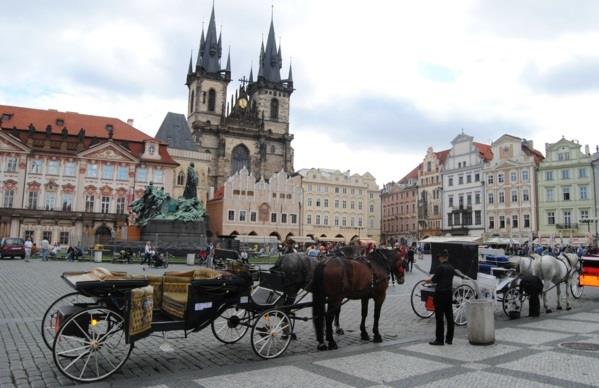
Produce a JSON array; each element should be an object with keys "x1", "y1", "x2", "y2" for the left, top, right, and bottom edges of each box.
[{"x1": 483, "y1": 135, "x2": 543, "y2": 242}]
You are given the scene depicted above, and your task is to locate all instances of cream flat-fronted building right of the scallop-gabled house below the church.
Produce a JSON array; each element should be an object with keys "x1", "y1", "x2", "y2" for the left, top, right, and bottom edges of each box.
[{"x1": 298, "y1": 168, "x2": 381, "y2": 243}]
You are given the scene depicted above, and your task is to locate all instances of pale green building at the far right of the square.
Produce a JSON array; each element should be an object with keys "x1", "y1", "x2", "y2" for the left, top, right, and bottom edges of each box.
[{"x1": 537, "y1": 138, "x2": 597, "y2": 244}]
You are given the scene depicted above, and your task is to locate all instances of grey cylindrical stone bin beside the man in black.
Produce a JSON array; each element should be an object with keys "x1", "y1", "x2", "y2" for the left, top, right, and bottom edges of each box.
[{"x1": 466, "y1": 299, "x2": 495, "y2": 345}]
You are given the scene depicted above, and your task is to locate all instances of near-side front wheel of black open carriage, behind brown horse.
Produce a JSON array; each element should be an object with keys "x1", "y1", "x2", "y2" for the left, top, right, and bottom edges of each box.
[{"x1": 252, "y1": 310, "x2": 293, "y2": 359}]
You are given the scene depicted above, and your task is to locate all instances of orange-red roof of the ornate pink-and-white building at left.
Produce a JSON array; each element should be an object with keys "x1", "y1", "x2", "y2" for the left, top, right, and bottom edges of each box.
[{"x1": 0, "y1": 105, "x2": 153, "y2": 142}]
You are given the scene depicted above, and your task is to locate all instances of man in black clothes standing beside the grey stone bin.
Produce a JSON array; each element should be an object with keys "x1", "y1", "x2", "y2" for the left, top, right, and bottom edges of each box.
[{"x1": 426, "y1": 249, "x2": 462, "y2": 345}]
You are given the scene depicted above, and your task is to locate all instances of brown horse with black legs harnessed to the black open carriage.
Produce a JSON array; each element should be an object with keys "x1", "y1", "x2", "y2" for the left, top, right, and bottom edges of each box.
[{"x1": 312, "y1": 249, "x2": 404, "y2": 350}]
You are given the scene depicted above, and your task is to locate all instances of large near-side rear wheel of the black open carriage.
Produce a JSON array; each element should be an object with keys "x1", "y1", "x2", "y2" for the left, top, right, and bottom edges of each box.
[{"x1": 52, "y1": 307, "x2": 133, "y2": 382}]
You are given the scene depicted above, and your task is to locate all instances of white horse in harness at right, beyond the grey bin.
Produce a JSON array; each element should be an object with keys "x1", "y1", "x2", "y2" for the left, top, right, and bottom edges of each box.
[{"x1": 510, "y1": 253, "x2": 578, "y2": 313}]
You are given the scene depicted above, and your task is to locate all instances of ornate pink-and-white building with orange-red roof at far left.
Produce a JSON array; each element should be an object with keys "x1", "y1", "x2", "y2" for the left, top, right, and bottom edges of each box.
[{"x1": 0, "y1": 105, "x2": 177, "y2": 246}]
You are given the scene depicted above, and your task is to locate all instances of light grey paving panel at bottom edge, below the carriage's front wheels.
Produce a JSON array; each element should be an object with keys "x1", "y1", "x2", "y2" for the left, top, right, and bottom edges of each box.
[{"x1": 194, "y1": 366, "x2": 351, "y2": 388}]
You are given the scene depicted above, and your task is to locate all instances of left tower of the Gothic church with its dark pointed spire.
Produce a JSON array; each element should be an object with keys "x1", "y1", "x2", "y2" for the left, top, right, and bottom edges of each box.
[{"x1": 185, "y1": 4, "x2": 231, "y2": 127}]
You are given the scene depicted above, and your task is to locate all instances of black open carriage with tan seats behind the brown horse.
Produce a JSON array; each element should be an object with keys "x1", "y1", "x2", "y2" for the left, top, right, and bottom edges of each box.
[{"x1": 41, "y1": 268, "x2": 310, "y2": 382}]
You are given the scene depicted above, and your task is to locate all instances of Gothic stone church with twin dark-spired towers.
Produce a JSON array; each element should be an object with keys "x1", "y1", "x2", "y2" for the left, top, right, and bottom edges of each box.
[{"x1": 175, "y1": 6, "x2": 294, "y2": 196}]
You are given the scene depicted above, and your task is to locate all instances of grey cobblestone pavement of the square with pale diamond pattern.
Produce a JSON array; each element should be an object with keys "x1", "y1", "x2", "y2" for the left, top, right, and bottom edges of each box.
[{"x1": 0, "y1": 260, "x2": 599, "y2": 388}]
